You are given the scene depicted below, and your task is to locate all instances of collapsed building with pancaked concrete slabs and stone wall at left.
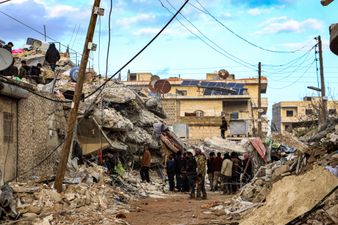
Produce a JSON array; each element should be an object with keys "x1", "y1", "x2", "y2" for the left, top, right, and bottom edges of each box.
[{"x1": 0, "y1": 38, "x2": 174, "y2": 184}]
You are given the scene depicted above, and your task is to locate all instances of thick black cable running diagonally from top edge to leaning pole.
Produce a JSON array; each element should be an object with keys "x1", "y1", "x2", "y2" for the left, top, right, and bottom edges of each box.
[{"x1": 84, "y1": 0, "x2": 189, "y2": 99}]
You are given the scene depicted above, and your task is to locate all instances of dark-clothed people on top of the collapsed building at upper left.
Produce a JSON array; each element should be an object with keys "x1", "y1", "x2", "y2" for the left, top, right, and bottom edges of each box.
[{"x1": 0, "y1": 42, "x2": 60, "y2": 83}]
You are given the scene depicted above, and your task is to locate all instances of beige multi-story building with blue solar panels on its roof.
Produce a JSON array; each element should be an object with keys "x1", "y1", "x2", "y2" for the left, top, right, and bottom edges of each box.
[{"x1": 125, "y1": 73, "x2": 268, "y2": 139}]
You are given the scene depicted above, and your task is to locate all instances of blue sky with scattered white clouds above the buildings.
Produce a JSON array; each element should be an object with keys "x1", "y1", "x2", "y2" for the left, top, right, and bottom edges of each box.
[{"x1": 0, "y1": 0, "x2": 338, "y2": 120}]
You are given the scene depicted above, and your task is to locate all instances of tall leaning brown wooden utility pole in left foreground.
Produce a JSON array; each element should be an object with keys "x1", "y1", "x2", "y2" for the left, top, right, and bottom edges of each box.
[{"x1": 55, "y1": 0, "x2": 101, "y2": 193}]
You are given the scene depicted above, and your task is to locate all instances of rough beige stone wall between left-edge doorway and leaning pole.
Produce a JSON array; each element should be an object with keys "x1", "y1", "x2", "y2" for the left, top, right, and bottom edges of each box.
[{"x1": 18, "y1": 93, "x2": 66, "y2": 178}]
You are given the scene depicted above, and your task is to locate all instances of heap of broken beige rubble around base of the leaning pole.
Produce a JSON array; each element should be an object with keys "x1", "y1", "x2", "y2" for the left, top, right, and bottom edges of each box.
[{"x1": 0, "y1": 164, "x2": 165, "y2": 224}]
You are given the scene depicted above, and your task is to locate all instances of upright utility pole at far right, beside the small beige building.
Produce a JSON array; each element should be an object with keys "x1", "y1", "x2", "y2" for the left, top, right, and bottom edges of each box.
[{"x1": 317, "y1": 36, "x2": 327, "y2": 124}]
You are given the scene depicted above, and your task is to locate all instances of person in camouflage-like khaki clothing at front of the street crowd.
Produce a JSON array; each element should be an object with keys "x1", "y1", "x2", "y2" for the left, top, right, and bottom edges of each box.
[{"x1": 195, "y1": 149, "x2": 207, "y2": 199}]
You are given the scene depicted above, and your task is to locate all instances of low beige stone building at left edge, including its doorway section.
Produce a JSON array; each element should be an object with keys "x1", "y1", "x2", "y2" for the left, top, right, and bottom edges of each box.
[{"x1": 0, "y1": 77, "x2": 66, "y2": 185}]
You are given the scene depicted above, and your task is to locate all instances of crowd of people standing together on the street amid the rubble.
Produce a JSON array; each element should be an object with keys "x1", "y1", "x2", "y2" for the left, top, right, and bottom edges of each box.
[{"x1": 166, "y1": 148, "x2": 253, "y2": 199}]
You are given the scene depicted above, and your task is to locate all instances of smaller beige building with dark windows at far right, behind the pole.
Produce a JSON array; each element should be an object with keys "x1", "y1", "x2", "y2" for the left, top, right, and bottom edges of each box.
[{"x1": 271, "y1": 97, "x2": 338, "y2": 133}]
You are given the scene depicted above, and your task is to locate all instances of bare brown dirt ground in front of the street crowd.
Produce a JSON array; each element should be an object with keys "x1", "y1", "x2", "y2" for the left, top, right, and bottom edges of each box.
[{"x1": 125, "y1": 192, "x2": 235, "y2": 225}]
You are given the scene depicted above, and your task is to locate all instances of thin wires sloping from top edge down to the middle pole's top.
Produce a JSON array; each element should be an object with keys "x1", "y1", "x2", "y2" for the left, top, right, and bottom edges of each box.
[{"x1": 158, "y1": 0, "x2": 256, "y2": 71}]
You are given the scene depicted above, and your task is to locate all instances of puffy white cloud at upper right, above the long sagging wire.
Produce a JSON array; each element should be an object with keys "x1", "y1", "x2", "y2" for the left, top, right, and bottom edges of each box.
[{"x1": 256, "y1": 16, "x2": 323, "y2": 34}]
